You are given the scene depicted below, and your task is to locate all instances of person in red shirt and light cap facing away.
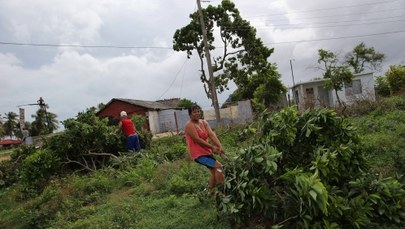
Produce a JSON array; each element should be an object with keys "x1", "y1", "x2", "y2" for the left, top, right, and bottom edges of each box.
[{"x1": 118, "y1": 111, "x2": 141, "y2": 152}]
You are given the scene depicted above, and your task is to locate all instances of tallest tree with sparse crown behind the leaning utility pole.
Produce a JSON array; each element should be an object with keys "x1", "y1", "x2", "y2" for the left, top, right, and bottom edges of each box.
[{"x1": 173, "y1": 0, "x2": 286, "y2": 111}]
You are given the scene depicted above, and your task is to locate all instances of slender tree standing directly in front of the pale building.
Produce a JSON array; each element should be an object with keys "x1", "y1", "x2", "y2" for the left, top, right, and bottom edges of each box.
[{"x1": 318, "y1": 49, "x2": 354, "y2": 106}]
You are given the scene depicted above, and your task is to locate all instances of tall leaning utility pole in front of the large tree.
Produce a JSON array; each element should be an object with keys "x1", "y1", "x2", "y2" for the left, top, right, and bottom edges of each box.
[{"x1": 197, "y1": 0, "x2": 221, "y2": 127}]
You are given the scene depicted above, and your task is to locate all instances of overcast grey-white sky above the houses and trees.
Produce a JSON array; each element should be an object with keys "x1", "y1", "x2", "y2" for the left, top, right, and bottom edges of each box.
[{"x1": 0, "y1": 0, "x2": 405, "y2": 127}]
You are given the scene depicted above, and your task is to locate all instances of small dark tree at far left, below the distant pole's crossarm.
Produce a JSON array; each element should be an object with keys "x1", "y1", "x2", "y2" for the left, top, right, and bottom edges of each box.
[{"x1": 30, "y1": 108, "x2": 58, "y2": 136}]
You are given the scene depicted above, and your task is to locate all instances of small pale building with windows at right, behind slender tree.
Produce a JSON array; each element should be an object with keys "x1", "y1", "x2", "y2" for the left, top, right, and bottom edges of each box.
[{"x1": 292, "y1": 73, "x2": 375, "y2": 110}]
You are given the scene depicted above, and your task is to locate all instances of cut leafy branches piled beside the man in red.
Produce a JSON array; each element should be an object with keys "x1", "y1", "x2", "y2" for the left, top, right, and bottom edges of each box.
[{"x1": 45, "y1": 109, "x2": 124, "y2": 171}]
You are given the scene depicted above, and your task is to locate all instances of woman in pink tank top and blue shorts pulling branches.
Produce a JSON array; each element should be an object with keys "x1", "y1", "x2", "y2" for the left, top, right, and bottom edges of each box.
[{"x1": 184, "y1": 105, "x2": 224, "y2": 193}]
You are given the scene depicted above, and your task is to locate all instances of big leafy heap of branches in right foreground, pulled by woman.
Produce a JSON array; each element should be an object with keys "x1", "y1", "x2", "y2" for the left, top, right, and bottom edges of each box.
[{"x1": 218, "y1": 108, "x2": 405, "y2": 228}]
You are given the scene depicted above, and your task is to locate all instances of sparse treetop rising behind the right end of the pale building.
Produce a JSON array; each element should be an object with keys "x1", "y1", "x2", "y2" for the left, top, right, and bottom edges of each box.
[{"x1": 345, "y1": 42, "x2": 385, "y2": 74}]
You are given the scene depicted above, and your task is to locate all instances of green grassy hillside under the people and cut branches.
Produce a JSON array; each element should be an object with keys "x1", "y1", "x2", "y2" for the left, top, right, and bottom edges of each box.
[{"x1": 0, "y1": 98, "x2": 405, "y2": 228}]
